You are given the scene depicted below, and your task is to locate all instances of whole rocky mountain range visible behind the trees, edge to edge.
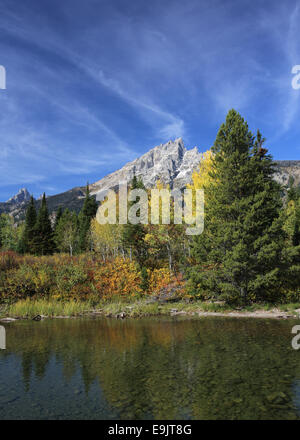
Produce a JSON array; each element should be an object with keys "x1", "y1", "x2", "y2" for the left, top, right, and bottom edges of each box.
[{"x1": 0, "y1": 138, "x2": 300, "y2": 222}]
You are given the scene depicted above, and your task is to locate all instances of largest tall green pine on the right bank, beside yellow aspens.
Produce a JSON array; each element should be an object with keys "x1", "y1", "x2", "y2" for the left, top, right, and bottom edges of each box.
[{"x1": 188, "y1": 110, "x2": 287, "y2": 303}]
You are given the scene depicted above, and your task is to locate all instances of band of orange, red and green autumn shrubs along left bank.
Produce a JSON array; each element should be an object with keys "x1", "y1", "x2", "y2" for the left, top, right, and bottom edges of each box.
[{"x1": 0, "y1": 249, "x2": 185, "y2": 304}]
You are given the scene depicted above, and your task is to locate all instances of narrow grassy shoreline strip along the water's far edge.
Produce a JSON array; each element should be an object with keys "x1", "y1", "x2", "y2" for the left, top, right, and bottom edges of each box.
[{"x1": 0, "y1": 300, "x2": 300, "y2": 323}]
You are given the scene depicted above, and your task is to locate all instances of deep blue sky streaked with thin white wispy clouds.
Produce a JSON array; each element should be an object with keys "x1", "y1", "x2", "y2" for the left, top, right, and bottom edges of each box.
[{"x1": 0, "y1": 0, "x2": 300, "y2": 201}]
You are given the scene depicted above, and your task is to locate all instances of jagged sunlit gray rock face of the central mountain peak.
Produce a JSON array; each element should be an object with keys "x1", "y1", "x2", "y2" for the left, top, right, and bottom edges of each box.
[{"x1": 90, "y1": 138, "x2": 202, "y2": 194}]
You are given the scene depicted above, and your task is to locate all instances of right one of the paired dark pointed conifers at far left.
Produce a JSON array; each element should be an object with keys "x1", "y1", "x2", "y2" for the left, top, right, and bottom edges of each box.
[{"x1": 34, "y1": 193, "x2": 55, "y2": 255}]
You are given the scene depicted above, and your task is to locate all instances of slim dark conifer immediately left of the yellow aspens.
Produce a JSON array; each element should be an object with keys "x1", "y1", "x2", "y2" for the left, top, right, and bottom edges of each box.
[{"x1": 78, "y1": 184, "x2": 98, "y2": 252}]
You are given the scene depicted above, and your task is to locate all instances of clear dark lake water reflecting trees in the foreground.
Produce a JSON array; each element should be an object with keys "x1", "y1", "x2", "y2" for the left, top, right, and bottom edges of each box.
[{"x1": 0, "y1": 317, "x2": 300, "y2": 420}]
